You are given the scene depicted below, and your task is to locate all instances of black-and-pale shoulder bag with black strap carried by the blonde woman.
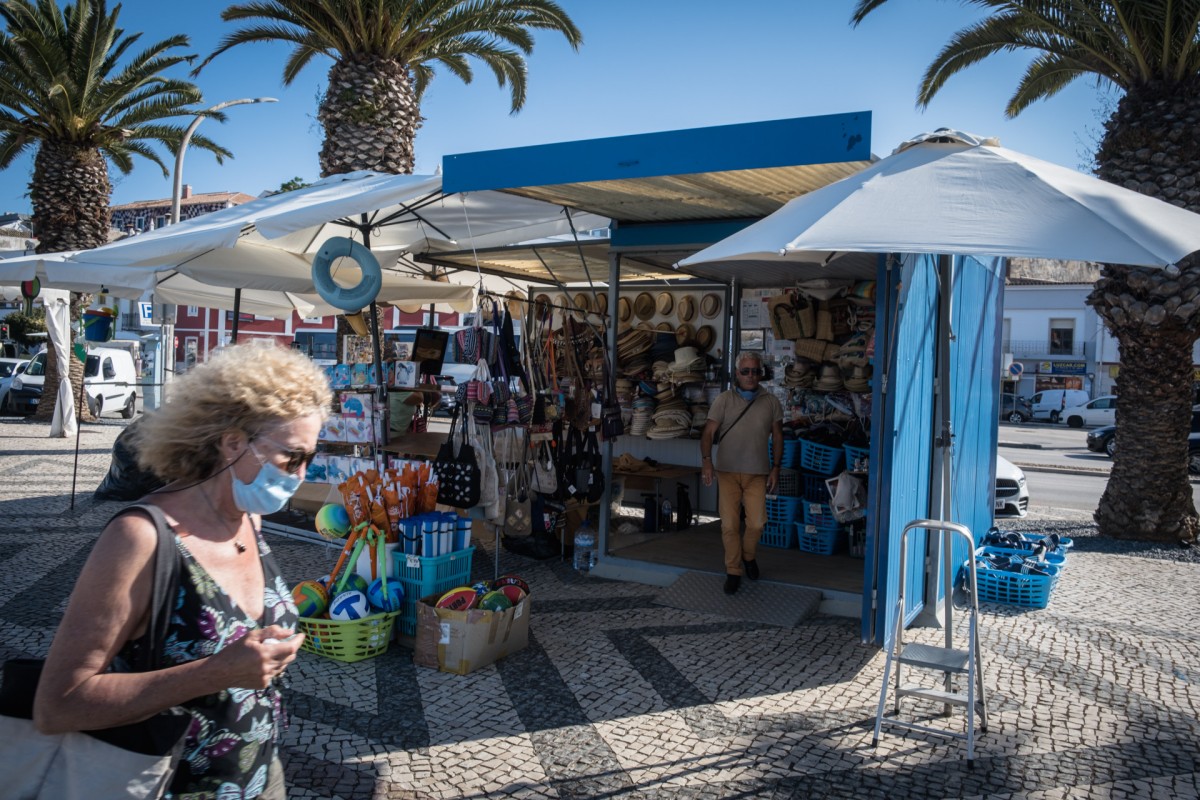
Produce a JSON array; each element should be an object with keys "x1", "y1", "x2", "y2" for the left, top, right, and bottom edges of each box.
[{"x1": 0, "y1": 505, "x2": 192, "y2": 800}]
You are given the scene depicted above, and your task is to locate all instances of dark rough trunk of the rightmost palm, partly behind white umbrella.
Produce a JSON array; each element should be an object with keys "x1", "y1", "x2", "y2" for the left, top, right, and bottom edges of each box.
[{"x1": 1087, "y1": 80, "x2": 1200, "y2": 543}]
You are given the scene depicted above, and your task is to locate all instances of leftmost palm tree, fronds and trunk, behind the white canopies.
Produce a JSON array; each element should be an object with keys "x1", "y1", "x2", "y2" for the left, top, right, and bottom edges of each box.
[{"x1": 0, "y1": 0, "x2": 230, "y2": 419}]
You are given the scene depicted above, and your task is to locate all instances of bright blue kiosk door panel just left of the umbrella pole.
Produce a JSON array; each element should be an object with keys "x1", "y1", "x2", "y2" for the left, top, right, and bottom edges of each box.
[{"x1": 863, "y1": 255, "x2": 938, "y2": 645}]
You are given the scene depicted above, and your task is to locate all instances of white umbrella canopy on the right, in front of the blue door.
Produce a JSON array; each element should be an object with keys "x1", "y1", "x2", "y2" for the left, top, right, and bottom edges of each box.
[{"x1": 679, "y1": 130, "x2": 1200, "y2": 266}]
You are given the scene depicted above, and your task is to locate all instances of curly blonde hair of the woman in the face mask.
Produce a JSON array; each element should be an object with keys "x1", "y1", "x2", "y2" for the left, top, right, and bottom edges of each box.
[{"x1": 131, "y1": 344, "x2": 332, "y2": 481}]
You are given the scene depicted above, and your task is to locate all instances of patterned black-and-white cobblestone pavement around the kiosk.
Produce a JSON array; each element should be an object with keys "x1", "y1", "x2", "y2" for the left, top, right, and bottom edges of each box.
[{"x1": 0, "y1": 420, "x2": 1200, "y2": 800}]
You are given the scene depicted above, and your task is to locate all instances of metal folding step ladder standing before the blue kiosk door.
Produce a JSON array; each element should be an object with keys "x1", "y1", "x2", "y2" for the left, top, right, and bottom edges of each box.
[{"x1": 871, "y1": 519, "x2": 988, "y2": 768}]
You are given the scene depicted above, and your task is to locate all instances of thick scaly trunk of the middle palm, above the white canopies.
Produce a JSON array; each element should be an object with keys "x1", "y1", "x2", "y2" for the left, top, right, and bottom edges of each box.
[{"x1": 318, "y1": 56, "x2": 421, "y2": 178}]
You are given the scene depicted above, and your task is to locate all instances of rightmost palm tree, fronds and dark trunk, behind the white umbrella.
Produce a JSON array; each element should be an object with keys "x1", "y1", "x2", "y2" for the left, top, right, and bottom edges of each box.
[{"x1": 852, "y1": 0, "x2": 1200, "y2": 542}]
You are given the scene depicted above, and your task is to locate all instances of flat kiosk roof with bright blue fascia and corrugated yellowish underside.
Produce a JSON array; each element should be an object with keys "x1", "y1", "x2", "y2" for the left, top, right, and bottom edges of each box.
[{"x1": 442, "y1": 112, "x2": 871, "y2": 227}]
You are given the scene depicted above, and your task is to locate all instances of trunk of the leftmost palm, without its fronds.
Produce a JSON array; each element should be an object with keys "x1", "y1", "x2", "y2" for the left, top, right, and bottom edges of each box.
[{"x1": 29, "y1": 140, "x2": 113, "y2": 422}]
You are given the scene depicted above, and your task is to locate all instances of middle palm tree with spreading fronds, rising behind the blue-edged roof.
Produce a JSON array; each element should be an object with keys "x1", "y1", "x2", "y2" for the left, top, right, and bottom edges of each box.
[{"x1": 193, "y1": 0, "x2": 582, "y2": 178}]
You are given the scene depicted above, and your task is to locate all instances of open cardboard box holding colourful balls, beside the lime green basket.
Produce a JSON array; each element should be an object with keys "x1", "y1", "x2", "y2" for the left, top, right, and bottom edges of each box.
[{"x1": 413, "y1": 595, "x2": 529, "y2": 675}]
